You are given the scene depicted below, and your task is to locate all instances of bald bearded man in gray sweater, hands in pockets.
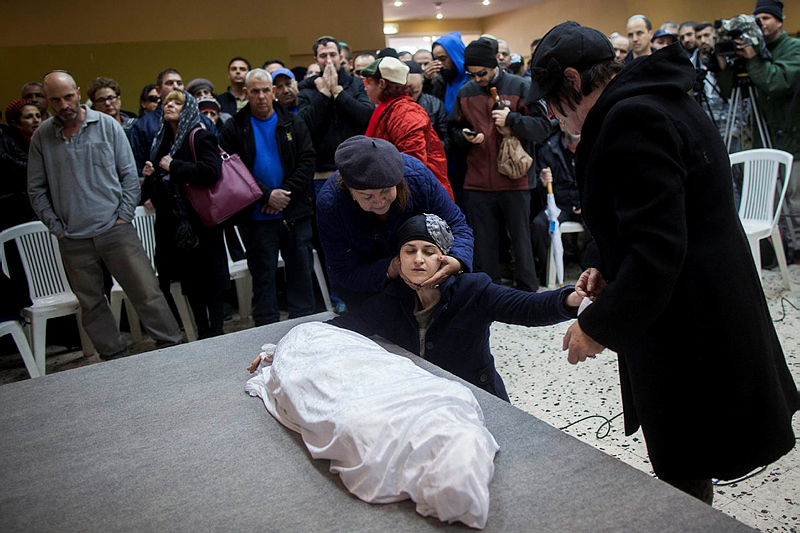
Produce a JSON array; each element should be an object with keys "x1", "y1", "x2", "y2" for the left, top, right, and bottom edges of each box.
[{"x1": 28, "y1": 71, "x2": 181, "y2": 359}]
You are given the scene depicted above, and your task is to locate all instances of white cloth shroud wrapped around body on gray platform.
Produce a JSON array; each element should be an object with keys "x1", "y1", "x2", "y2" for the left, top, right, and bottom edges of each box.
[{"x1": 246, "y1": 322, "x2": 499, "y2": 528}]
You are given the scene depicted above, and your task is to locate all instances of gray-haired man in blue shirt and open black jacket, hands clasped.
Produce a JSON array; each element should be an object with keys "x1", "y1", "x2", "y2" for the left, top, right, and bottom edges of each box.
[{"x1": 220, "y1": 68, "x2": 315, "y2": 326}]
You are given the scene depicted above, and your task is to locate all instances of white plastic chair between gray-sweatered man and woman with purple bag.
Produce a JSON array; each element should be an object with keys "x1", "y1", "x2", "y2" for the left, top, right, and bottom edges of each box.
[{"x1": 111, "y1": 205, "x2": 197, "y2": 342}]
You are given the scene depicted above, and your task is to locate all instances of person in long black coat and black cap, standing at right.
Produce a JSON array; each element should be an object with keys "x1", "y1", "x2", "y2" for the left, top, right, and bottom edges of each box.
[{"x1": 531, "y1": 22, "x2": 800, "y2": 503}]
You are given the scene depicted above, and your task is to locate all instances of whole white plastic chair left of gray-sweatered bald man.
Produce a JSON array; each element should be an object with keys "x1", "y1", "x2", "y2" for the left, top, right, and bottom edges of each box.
[{"x1": 0, "y1": 221, "x2": 94, "y2": 376}]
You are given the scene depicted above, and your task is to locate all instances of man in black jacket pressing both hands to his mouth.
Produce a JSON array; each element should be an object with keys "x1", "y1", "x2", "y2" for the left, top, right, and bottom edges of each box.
[{"x1": 297, "y1": 36, "x2": 373, "y2": 186}]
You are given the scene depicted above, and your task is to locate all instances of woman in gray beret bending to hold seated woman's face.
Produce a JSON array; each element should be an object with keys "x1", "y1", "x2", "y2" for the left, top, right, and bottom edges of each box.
[{"x1": 317, "y1": 135, "x2": 473, "y2": 308}]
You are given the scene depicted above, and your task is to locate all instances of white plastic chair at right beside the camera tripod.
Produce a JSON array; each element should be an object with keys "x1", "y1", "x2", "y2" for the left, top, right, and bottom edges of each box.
[{"x1": 730, "y1": 148, "x2": 794, "y2": 290}]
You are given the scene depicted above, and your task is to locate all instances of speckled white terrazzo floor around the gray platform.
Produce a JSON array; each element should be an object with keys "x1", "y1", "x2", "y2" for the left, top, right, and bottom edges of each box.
[{"x1": 0, "y1": 264, "x2": 800, "y2": 533}]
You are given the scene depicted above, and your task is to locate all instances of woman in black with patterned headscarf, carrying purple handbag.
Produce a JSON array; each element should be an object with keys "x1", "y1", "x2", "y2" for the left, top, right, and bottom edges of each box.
[{"x1": 143, "y1": 91, "x2": 230, "y2": 339}]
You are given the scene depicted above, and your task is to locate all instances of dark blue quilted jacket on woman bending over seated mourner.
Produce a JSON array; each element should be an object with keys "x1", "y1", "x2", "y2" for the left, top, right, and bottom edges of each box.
[{"x1": 317, "y1": 154, "x2": 473, "y2": 306}]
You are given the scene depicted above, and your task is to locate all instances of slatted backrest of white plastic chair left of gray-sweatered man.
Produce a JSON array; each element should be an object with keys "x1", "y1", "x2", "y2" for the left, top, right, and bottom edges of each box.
[{"x1": 0, "y1": 221, "x2": 72, "y2": 307}]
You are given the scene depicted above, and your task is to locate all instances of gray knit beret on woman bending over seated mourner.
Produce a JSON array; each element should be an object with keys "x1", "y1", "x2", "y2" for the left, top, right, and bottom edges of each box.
[{"x1": 334, "y1": 135, "x2": 403, "y2": 190}]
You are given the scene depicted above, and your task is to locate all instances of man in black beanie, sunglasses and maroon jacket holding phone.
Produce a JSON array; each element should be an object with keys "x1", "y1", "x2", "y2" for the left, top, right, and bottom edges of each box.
[{"x1": 449, "y1": 39, "x2": 550, "y2": 292}]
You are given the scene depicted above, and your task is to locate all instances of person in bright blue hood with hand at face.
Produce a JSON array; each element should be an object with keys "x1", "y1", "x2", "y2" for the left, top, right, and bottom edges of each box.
[{"x1": 422, "y1": 31, "x2": 469, "y2": 115}]
